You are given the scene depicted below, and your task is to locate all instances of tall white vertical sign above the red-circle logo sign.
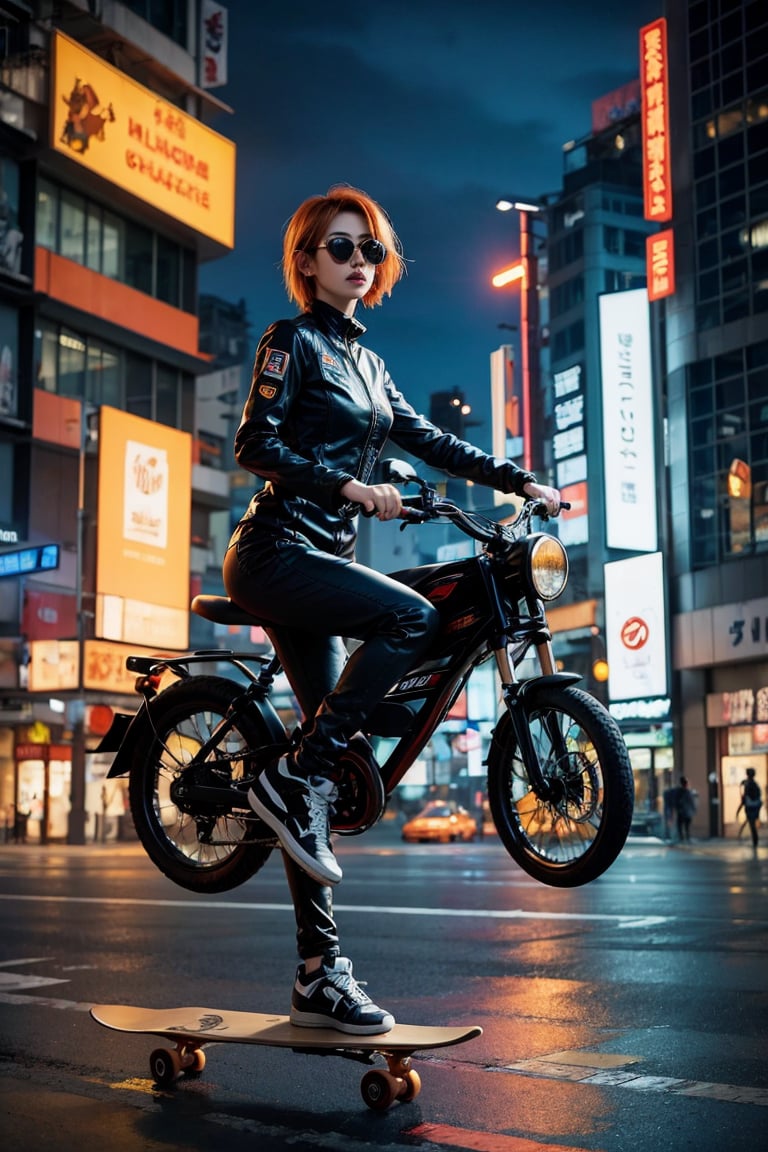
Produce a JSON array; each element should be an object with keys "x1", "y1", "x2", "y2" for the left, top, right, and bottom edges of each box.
[{"x1": 599, "y1": 288, "x2": 657, "y2": 552}]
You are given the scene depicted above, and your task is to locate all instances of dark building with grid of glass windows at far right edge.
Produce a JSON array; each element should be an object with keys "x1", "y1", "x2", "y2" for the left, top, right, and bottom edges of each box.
[{"x1": 655, "y1": 0, "x2": 768, "y2": 835}]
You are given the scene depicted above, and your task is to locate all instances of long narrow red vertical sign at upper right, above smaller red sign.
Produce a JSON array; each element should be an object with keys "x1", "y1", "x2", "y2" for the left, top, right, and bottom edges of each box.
[{"x1": 640, "y1": 18, "x2": 672, "y2": 221}]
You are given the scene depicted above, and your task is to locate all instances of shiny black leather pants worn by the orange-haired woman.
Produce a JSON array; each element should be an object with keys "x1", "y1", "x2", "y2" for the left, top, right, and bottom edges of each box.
[{"x1": 223, "y1": 533, "x2": 439, "y2": 958}]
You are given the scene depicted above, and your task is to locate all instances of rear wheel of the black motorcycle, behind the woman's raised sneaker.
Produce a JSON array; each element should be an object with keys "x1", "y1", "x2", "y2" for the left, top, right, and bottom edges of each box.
[{"x1": 128, "y1": 676, "x2": 282, "y2": 893}]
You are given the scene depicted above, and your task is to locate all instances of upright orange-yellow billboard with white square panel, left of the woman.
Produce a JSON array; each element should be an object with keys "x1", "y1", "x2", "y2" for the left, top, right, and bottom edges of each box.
[{"x1": 96, "y1": 406, "x2": 192, "y2": 649}]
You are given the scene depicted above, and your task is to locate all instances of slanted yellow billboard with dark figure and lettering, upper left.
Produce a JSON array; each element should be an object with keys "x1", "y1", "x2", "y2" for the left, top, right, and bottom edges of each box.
[{"x1": 51, "y1": 32, "x2": 235, "y2": 248}]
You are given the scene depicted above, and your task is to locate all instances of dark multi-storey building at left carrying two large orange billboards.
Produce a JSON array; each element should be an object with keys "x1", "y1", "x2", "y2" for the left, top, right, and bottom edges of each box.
[{"x1": 0, "y1": 0, "x2": 237, "y2": 843}]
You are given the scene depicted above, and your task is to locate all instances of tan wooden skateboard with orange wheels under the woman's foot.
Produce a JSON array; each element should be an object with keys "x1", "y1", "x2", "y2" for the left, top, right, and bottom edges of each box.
[{"x1": 91, "y1": 1005, "x2": 482, "y2": 1112}]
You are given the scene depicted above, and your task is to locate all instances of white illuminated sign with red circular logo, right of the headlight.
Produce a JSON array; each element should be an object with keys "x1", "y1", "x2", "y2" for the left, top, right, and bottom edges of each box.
[{"x1": 603, "y1": 552, "x2": 667, "y2": 702}]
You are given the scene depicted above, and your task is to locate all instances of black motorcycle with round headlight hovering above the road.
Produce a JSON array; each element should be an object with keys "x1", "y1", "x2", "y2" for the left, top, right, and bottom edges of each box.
[{"x1": 97, "y1": 461, "x2": 634, "y2": 893}]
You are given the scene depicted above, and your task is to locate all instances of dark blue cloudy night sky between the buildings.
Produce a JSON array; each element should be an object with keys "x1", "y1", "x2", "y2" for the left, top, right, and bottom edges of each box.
[{"x1": 200, "y1": 0, "x2": 663, "y2": 449}]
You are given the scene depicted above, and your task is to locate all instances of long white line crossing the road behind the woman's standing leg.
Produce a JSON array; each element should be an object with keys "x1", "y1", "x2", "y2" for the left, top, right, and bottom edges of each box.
[{"x1": 0, "y1": 893, "x2": 677, "y2": 929}]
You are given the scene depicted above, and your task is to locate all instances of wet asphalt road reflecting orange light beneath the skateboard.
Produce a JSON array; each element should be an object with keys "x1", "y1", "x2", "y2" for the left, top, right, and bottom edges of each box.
[{"x1": 0, "y1": 824, "x2": 768, "y2": 1152}]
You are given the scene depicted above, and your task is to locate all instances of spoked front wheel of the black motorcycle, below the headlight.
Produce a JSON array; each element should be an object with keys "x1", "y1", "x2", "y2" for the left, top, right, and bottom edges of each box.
[{"x1": 488, "y1": 682, "x2": 634, "y2": 888}]
